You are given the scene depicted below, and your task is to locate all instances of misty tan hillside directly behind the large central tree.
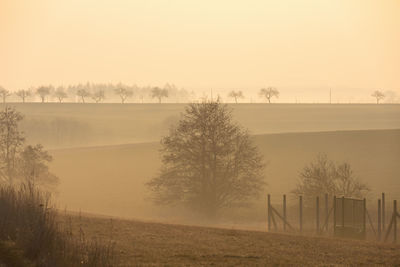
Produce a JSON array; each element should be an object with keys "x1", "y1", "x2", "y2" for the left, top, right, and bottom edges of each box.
[{"x1": 51, "y1": 130, "x2": 400, "y2": 227}]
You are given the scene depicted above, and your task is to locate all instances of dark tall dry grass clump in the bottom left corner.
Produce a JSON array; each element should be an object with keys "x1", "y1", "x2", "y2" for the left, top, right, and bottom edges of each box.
[{"x1": 0, "y1": 184, "x2": 116, "y2": 267}]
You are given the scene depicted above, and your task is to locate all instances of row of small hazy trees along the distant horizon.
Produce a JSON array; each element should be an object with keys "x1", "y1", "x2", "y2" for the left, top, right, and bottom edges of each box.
[{"x1": 0, "y1": 82, "x2": 386, "y2": 104}]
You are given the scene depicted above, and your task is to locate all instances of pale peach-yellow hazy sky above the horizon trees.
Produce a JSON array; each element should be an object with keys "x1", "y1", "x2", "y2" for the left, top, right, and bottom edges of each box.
[{"x1": 0, "y1": 0, "x2": 400, "y2": 102}]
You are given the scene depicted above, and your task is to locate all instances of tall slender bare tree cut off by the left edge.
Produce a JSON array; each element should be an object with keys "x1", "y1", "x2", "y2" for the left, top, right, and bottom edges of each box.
[{"x1": 0, "y1": 107, "x2": 25, "y2": 184}]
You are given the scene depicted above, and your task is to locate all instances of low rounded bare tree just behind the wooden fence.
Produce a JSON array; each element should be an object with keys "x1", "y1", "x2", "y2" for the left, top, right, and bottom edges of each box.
[{"x1": 293, "y1": 154, "x2": 369, "y2": 202}]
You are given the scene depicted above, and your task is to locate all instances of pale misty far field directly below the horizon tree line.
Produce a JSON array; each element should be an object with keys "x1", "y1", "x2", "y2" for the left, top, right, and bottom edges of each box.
[{"x1": 0, "y1": 103, "x2": 400, "y2": 148}]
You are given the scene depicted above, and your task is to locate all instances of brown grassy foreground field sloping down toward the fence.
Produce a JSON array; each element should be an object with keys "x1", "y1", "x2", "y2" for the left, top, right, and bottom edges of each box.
[{"x1": 72, "y1": 216, "x2": 400, "y2": 266}]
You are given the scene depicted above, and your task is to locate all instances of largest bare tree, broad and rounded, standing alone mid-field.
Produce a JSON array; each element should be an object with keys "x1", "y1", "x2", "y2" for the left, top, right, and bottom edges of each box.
[{"x1": 148, "y1": 101, "x2": 265, "y2": 217}]
